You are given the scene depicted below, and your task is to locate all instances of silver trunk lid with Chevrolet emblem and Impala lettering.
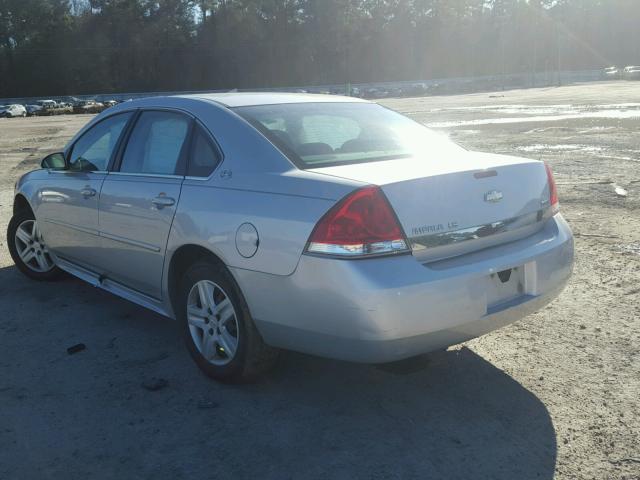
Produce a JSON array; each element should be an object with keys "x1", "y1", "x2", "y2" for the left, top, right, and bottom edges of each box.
[{"x1": 313, "y1": 150, "x2": 549, "y2": 262}]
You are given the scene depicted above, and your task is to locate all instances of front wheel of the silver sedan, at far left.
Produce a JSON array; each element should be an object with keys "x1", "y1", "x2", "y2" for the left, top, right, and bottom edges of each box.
[{"x1": 7, "y1": 210, "x2": 62, "y2": 281}]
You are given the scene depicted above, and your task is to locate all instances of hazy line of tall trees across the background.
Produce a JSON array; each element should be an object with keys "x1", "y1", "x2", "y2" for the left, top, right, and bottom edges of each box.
[{"x1": 0, "y1": 0, "x2": 640, "y2": 97}]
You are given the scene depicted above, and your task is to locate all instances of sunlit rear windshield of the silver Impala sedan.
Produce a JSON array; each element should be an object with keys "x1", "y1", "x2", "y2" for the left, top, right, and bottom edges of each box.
[{"x1": 234, "y1": 103, "x2": 461, "y2": 169}]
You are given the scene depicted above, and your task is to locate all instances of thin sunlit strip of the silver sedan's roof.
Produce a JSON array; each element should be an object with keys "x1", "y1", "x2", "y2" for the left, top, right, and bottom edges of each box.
[{"x1": 179, "y1": 92, "x2": 369, "y2": 108}]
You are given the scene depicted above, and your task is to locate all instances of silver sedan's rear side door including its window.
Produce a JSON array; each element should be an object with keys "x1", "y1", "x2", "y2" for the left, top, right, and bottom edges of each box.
[{"x1": 99, "y1": 110, "x2": 193, "y2": 299}]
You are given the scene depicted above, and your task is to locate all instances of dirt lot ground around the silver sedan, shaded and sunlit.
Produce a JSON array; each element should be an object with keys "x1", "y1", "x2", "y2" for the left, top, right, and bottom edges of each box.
[{"x1": 0, "y1": 82, "x2": 640, "y2": 479}]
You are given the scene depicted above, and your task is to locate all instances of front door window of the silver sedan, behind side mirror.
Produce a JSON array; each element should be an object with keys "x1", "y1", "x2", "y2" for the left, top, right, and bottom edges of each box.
[{"x1": 69, "y1": 112, "x2": 132, "y2": 172}]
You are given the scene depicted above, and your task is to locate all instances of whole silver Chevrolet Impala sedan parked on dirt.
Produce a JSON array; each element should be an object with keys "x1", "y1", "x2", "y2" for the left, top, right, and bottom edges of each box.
[{"x1": 8, "y1": 93, "x2": 573, "y2": 381}]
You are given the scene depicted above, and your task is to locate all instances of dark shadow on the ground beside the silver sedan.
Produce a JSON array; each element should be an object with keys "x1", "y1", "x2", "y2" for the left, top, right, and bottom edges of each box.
[{"x1": 0, "y1": 267, "x2": 556, "y2": 479}]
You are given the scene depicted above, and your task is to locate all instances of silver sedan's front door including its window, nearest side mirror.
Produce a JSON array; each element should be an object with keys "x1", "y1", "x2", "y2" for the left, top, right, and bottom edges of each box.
[{"x1": 37, "y1": 112, "x2": 133, "y2": 271}]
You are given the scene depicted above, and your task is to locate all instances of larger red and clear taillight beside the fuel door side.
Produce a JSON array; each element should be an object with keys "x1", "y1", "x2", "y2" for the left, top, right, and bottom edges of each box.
[{"x1": 307, "y1": 187, "x2": 408, "y2": 257}]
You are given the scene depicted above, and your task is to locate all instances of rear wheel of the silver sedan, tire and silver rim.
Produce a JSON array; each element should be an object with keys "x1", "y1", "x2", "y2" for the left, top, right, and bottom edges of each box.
[{"x1": 176, "y1": 260, "x2": 277, "y2": 383}]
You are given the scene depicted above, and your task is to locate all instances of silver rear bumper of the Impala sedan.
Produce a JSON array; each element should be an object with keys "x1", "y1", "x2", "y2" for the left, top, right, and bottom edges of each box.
[{"x1": 233, "y1": 215, "x2": 573, "y2": 363}]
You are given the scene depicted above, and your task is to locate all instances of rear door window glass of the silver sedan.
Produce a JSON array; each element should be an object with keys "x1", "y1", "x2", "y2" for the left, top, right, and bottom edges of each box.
[{"x1": 120, "y1": 111, "x2": 191, "y2": 175}]
